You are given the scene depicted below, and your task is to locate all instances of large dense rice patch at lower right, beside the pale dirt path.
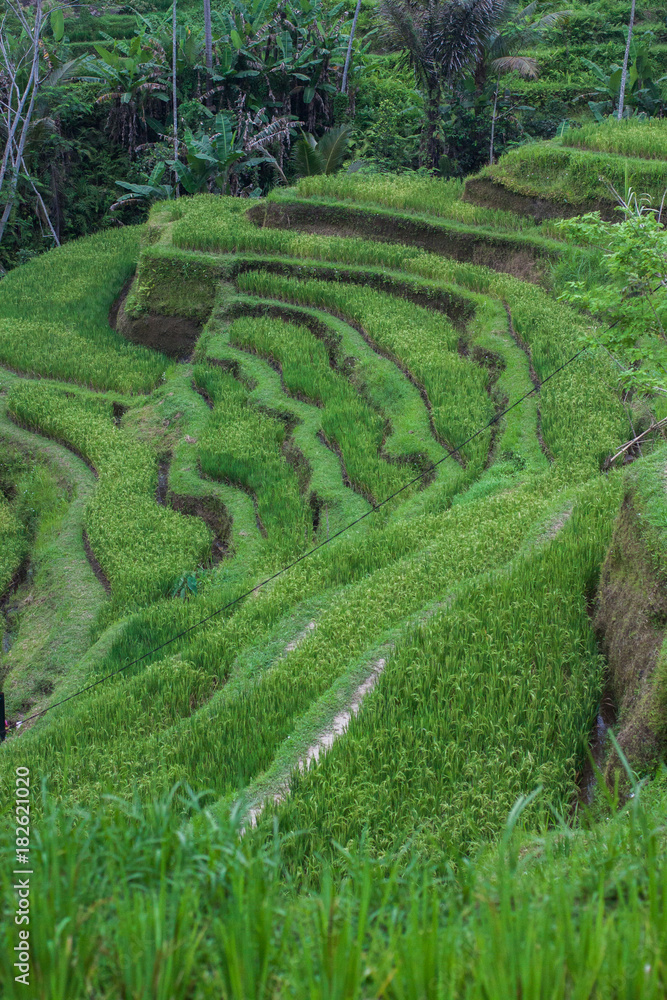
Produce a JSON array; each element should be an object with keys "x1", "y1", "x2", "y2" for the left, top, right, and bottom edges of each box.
[{"x1": 268, "y1": 479, "x2": 620, "y2": 866}]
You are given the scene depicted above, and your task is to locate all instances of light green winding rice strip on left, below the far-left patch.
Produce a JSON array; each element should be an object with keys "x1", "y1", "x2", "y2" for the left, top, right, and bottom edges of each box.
[{"x1": 7, "y1": 380, "x2": 210, "y2": 606}]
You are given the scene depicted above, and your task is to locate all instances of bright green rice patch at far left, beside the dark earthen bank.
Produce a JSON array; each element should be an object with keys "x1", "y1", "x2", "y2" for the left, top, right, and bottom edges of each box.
[{"x1": 0, "y1": 227, "x2": 167, "y2": 393}]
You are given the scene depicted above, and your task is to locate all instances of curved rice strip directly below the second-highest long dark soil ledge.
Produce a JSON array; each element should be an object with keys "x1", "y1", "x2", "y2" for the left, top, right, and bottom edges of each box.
[{"x1": 237, "y1": 272, "x2": 492, "y2": 469}]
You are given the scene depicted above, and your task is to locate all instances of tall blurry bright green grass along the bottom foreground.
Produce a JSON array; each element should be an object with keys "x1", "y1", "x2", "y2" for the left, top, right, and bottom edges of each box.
[{"x1": 0, "y1": 768, "x2": 667, "y2": 1000}]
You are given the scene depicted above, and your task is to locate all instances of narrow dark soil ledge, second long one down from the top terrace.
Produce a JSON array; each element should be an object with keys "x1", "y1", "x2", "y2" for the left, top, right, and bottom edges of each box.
[{"x1": 236, "y1": 257, "x2": 474, "y2": 326}]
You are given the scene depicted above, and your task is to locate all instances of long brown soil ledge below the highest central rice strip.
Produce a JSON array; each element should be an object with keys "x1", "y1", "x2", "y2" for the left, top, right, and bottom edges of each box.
[{"x1": 248, "y1": 202, "x2": 549, "y2": 283}]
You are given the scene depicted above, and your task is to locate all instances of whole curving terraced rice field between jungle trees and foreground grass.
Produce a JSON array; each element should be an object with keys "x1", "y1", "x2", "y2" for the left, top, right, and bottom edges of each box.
[{"x1": 0, "y1": 174, "x2": 629, "y2": 870}]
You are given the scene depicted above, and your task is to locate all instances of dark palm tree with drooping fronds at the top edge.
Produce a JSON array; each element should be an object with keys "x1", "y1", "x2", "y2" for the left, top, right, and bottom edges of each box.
[{"x1": 380, "y1": 0, "x2": 507, "y2": 166}]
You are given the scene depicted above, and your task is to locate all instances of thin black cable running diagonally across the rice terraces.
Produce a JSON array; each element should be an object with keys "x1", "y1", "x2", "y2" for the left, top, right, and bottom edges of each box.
[{"x1": 6, "y1": 347, "x2": 588, "y2": 729}]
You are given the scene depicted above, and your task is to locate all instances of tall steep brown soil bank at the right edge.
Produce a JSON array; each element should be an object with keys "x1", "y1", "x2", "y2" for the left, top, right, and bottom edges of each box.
[{"x1": 594, "y1": 493, "x2": 667, "y2": 782}]
